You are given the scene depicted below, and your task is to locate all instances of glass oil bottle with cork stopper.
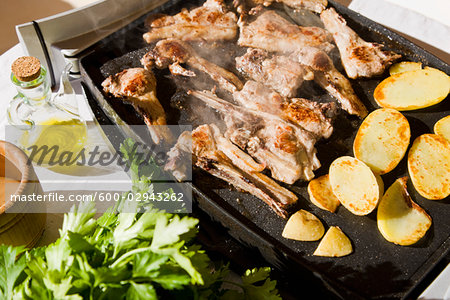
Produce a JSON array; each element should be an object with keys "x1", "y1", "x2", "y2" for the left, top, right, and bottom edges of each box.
[{"x1": 7, "y1": 56, "x2": 87, "y2": 164}]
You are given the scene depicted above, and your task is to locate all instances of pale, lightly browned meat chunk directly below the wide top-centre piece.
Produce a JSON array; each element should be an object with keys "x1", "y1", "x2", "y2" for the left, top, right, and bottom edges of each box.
[{"x1": 236, "y1": 48, "x2": 308, "y2": 97}]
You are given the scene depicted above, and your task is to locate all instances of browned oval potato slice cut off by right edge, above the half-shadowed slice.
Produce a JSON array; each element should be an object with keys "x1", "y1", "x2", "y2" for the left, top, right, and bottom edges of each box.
[{"x1": 408, "y1": 134, "x2": 450, "y2": 200}]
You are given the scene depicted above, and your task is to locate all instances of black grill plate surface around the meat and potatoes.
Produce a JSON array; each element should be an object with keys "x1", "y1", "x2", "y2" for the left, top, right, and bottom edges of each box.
[{"x1": 81, "y1": 0, "x2": 450, "y2": 298}]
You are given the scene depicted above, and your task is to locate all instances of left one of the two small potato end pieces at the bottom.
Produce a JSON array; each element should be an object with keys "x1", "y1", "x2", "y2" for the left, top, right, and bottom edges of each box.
[{"x1": 281, "y1": 209, "x2": 325, "y2": 241}]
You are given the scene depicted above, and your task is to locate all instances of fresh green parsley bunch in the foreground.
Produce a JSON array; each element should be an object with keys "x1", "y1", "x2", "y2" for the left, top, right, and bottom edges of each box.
[{"x1": 0, "y1": 141, "x2": 280, "y2": 300}]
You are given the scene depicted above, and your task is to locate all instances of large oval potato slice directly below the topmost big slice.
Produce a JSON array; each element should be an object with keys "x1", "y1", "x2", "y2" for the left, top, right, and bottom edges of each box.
[{"x1": 353, "y1": 108, "x2": 411, "y2": 174}]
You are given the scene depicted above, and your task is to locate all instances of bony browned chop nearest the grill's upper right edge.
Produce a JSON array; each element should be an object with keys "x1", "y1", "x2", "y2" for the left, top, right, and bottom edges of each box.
[{"x1": 320, "y1": 8, "x2": 401, "y2": 78}]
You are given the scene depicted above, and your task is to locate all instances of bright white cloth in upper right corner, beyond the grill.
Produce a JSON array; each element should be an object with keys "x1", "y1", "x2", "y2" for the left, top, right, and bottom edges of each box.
[{"x1": 349, "y1": 0, "x2": 450, "y2": 53}]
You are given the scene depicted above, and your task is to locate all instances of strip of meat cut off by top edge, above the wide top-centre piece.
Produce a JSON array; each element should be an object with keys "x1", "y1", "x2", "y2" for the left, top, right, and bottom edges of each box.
[{"x1": 233, "y1": 0, "x2": 328, "y2": 14}]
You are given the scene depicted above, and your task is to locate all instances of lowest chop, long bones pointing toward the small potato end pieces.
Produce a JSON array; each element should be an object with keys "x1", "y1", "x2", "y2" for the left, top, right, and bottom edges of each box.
[{"x1": 166, "y1": 124, "x2": 298, "y2": 218}]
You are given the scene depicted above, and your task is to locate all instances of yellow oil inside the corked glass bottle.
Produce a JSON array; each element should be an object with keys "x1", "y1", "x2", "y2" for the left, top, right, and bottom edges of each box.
[{"x1": 21, "y1": 118, "x2": 87, "y2": 167}]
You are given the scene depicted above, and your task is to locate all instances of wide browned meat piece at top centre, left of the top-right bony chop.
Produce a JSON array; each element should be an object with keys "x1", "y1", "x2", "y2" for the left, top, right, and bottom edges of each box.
[{"x1": 238, "y1": 10, "x2": 334, "y2": 53}]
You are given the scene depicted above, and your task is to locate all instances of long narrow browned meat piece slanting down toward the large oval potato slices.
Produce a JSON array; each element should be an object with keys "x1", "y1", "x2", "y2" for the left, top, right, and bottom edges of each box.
[{"x1": 291, "y1": 47, "x2": 367, "y2": 118}]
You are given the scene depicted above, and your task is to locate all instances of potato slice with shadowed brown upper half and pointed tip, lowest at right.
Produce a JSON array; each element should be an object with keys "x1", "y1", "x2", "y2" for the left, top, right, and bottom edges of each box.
[{"x1": 377, "y1": 177, "x2": 431, "y2": 246}]
